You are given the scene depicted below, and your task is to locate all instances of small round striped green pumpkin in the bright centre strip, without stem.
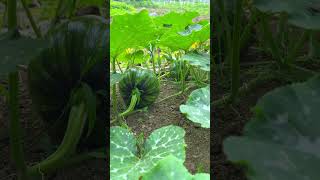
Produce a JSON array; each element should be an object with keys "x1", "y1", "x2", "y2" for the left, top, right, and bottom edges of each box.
[{"x1": 119, "y1": 68, "x2": 160, "y2": 109}]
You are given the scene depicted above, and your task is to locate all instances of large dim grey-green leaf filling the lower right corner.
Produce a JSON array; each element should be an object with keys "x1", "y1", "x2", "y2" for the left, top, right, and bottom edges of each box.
[{"x1": 224, "y1": 76, "x2": 320, "y2": 180}]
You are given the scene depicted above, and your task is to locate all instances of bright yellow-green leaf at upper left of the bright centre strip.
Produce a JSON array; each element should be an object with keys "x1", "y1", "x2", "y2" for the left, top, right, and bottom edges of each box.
[{"x1": 110, "y1": 10, "x2": 157, "y2": 58}]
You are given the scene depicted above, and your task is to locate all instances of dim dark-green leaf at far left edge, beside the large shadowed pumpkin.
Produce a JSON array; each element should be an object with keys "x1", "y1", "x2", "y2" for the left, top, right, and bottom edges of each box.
[{"x1": 0, "y1": 37, "x2": 47, "y2": 76}]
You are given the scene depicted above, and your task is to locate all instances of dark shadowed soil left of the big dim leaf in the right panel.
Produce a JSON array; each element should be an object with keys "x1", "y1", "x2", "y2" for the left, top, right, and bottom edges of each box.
[{"x1": 211, "y1": 78, "x2": 281, "y2": 180}]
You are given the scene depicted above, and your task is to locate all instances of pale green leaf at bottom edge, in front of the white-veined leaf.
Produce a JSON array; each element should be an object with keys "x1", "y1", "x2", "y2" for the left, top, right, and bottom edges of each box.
[{"x1": 142, "y1": 155, "x2": 210, "y2": 180}]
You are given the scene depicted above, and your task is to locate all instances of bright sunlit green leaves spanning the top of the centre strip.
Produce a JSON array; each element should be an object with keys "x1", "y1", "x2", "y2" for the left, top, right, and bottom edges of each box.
[{"x1": 110, "y1": 10, "x2": 210, "y2": 61}]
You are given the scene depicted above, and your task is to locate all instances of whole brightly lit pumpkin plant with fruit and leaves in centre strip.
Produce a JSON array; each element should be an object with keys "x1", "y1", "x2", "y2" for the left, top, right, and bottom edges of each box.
[{"x1": 110, "y1": 10, "x2": 210, "y2": 180}]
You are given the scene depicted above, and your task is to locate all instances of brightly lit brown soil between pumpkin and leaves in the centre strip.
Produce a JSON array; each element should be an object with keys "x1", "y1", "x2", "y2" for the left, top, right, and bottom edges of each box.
[{"x1": 111, "y1": 81, "x2": 210, "y2": 173}]
